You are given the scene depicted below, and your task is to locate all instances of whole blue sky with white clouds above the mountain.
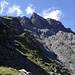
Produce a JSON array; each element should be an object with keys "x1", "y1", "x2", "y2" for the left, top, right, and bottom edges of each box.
[{"x1": 0, "y1": 0, "x2": 75, "y2": 32}]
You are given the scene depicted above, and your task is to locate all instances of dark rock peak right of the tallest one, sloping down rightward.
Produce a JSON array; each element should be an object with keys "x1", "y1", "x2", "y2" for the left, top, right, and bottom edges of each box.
[{"x1": 47, "y1": 18, "x2": 74, "y2": 34}]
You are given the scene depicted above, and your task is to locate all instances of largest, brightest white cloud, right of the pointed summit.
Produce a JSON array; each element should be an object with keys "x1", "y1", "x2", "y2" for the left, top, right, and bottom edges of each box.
[{"x1": 42, "y1": 8, "x2": 63, "y2": 20}]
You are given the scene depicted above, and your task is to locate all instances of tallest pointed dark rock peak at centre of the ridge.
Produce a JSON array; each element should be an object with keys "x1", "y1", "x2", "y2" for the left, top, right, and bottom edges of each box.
[{"x1": 30, "y1": 13, "x2": 50, "y2": 29}]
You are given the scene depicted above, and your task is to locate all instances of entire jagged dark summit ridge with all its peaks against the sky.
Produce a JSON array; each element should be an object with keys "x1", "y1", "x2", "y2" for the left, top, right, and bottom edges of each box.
[{"x1": 20, "y1": 13, "x2": 74, "y2": 35}]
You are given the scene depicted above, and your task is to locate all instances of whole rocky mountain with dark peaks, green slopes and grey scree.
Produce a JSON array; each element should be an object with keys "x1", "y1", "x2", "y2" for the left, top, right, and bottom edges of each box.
[{"x1": 0, "y1": 13, "x2": 75, "y2": 75}]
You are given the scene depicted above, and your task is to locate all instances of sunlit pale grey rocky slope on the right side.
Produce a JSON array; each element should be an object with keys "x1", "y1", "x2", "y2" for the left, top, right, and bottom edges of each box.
[{"x1": 43, "y1": 31, "x2": 75, "y2": 70}]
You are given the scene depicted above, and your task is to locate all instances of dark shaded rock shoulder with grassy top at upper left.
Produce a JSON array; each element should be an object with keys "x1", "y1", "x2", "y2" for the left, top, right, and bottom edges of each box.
[{"x1": 0, "y1": 16, "x2": 23, "y2": 34}]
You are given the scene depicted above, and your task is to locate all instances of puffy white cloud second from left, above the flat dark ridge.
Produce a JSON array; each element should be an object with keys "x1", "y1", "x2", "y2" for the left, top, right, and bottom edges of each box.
[{"x1": 7, "y1": 5, "x2": 23, "y2": 16}]
